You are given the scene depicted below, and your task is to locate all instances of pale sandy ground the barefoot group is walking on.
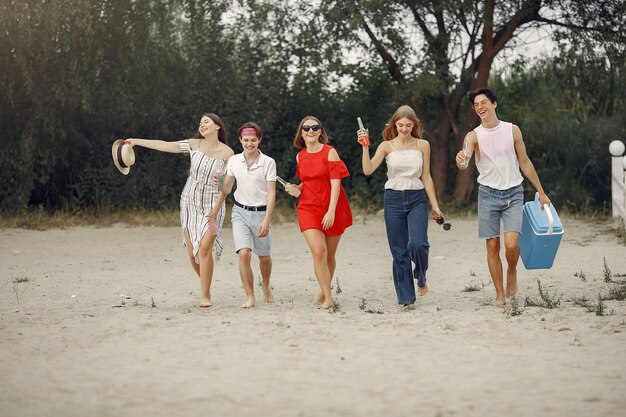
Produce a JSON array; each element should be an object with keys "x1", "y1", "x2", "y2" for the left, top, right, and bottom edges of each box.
[{"x1": 0, "y1": 216, "x2": 626, "y2": 417}]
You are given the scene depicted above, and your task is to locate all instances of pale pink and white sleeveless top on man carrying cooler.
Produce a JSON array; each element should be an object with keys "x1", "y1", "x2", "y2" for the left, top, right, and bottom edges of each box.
[{"x1": 474, "y1": 121, "x2": 524, "y2": 190}]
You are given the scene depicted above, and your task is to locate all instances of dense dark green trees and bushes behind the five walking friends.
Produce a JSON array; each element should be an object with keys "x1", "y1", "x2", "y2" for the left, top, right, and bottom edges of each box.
[{"x1": 0, "y1": 0, "x2": 626, "y2": 212}]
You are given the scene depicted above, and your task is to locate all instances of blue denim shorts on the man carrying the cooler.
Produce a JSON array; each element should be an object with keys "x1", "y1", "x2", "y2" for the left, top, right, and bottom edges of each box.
[{"x1": 478, "y1": 184, "x2": 524, "y2": 239}]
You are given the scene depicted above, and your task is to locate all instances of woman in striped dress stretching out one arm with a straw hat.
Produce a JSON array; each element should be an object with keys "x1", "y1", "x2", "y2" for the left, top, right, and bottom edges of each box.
[{"x1": 125, "y1": 113, "x2": 234, "y2": 308}]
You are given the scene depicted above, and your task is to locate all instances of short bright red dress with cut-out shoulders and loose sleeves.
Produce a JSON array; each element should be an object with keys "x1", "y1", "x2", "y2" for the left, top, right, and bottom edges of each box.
[{"x1": 296, "y1": 145, "x2": 352, "y2": 236}]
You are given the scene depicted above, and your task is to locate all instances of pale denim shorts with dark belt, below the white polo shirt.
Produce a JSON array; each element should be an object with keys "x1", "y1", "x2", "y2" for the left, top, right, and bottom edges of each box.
[{"x1": 231, "y1": 205, "x2": 272, "y2": 256}]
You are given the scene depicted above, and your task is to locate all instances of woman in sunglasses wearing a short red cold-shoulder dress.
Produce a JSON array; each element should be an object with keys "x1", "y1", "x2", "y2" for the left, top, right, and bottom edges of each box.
[{"x1": 286, "y1": 116, "x2": 352, "y2": 309}]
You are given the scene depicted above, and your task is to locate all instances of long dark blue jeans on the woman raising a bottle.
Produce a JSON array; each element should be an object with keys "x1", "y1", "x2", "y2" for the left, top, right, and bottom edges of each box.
[{"x1": 385, "y1": 189, "x2": 430, "y2": 304}]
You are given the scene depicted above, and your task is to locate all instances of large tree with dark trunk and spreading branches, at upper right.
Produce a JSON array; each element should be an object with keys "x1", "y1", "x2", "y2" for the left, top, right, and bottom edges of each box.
[{"x1": 299, "y1": 0, "x2": 625, "y2": 201}]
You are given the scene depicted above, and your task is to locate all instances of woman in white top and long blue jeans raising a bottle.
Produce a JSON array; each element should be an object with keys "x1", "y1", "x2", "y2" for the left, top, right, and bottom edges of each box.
[{"x1": 358, "y1": 106, "x2": 443, "y2": 306}]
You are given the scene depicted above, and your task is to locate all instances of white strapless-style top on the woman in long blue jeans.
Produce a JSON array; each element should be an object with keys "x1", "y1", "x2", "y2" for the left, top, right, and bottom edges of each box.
[{"x1": 385, "y1": 142, "x2": 424, "y2": 191}]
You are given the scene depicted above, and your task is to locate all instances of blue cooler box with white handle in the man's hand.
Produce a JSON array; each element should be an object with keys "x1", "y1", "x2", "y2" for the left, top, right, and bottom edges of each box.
[{"x1": 519, "y1": 193, "x2": 563, "y2": 269}]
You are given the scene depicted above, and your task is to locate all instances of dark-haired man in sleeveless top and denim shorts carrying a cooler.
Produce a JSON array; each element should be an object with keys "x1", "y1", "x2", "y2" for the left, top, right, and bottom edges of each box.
[{"x1": 456, "y1": 88, "x2": 550, "y2": 307}]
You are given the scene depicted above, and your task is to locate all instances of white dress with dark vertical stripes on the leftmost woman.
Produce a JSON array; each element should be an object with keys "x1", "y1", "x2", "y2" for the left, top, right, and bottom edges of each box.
[{"x1": 178, "y1": 139, "x2": 225, "y2": 264}]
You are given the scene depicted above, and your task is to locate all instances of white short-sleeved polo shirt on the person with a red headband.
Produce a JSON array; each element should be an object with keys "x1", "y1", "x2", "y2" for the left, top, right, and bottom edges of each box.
[{"x1": 226, "y1": 150, "x2": 276, "y2": 207}]
